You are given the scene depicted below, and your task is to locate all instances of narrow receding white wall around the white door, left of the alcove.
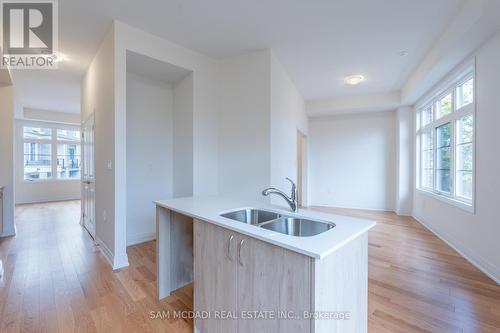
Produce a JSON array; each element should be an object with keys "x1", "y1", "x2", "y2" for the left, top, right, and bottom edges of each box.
[{"x1": 81, "y1": 28, "x2": 119, "y2": 268}]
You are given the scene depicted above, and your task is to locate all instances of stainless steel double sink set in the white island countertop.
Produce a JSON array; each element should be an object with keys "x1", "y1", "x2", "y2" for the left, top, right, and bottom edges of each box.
[{"x1": 220, "y1": 208, "x2": 335, "y2": 237}]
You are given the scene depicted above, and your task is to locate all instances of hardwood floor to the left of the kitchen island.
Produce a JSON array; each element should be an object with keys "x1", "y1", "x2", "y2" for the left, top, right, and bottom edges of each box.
[{"x1": 0, "y1": 201, "x2": 192, "y2": 333}]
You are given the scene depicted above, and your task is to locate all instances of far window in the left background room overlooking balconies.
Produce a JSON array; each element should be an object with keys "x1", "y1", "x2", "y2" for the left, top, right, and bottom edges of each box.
[{"x1": 22, "y1": 125, "x2": 81, "y2": 181}]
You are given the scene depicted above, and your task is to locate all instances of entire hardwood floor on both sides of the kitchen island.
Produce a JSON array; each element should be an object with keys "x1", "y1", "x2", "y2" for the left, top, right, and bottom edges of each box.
[{"x1": 0, "y1": 201, "x2": 500, "y2": 333}]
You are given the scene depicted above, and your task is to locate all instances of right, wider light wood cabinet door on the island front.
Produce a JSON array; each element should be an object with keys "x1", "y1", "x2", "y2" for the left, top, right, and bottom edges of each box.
[{"x1": 237, "y1": 236, "x2": 311, "y2": 333}]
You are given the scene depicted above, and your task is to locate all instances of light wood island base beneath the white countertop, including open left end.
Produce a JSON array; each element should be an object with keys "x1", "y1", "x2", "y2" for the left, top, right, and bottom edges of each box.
[{"x1": 156, "y1": 206, "x2": 368, "y2": 333}]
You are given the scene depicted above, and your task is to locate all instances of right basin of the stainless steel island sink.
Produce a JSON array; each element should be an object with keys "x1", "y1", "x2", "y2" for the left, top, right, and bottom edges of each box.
[{"x1": 260, "y1": 216, "x2": 335, "y2": 237}]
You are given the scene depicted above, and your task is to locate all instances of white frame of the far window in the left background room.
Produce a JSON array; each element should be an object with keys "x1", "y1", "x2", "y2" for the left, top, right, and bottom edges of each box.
[{"x1": 16, "y1": 120, "x2": 83, "y2": 184}]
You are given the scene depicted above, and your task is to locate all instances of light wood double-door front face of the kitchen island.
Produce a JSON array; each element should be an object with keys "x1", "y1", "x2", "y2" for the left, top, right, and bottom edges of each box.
[{"x1": 194, "y1": 220, "x2": 312, "y2": 333}]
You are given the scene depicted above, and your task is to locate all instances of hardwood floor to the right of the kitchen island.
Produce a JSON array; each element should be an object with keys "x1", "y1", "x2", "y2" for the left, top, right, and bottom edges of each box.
[{"x1": 314, "y1": 207, "x2": 500, "y2": 333}]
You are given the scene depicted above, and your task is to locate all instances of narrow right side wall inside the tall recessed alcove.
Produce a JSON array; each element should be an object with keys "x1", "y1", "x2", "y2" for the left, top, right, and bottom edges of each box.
[{"x1": 173, "y1": 74, "x2": 194, "y2": 197}]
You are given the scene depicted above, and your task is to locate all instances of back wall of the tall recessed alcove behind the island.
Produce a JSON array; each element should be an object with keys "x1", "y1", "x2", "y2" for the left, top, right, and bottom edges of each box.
[{"x1": 127, "y1": 73, "x2": 174, "y2": 245}]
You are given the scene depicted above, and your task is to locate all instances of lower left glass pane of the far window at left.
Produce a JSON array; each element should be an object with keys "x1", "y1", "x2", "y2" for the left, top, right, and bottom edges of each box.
[{"x1": 23, "y1": 142, "x2": 52, "y2": 180}]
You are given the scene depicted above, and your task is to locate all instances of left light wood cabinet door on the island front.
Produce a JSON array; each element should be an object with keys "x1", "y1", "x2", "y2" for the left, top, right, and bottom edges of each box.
[{"x1": 193, "y1": 220, "x2": 237, "y2": 333}]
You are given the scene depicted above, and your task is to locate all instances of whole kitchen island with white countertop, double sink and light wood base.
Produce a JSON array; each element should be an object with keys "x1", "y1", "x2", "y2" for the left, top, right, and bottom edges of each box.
[{"x1": 155, "y1": 196, "x2": 375, "y2": 333}]
